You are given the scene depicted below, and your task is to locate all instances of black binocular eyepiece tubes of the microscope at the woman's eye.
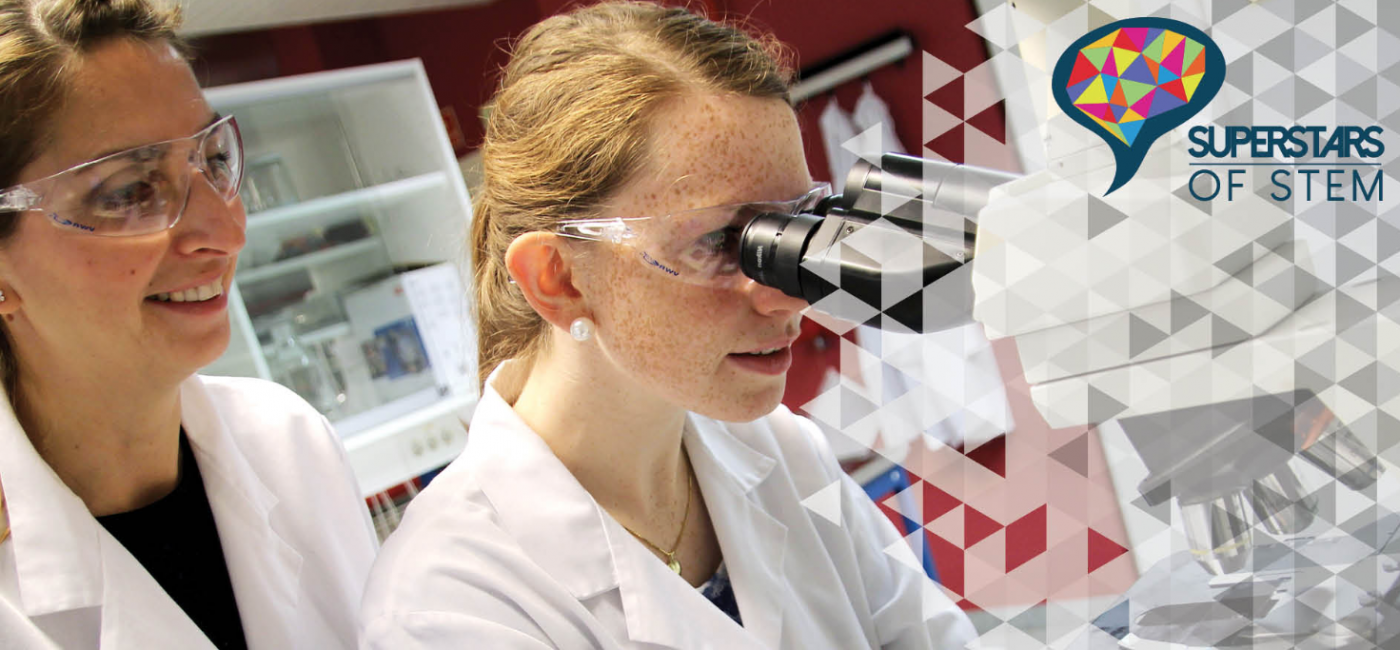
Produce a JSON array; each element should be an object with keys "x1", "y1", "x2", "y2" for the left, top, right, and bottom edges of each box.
[{"x1": 739, "y1": 154, "x2": 1016, "y2": 332}]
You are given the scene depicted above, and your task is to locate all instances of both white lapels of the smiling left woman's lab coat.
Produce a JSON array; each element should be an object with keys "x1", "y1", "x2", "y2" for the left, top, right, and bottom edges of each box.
[{"x1": 0, "y1": 377, "x2": 302, "y2": 649}]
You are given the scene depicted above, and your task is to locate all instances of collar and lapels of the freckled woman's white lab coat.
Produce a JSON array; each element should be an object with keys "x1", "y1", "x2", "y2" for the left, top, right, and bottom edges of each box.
[{"x1": 463, "y1": 361, "x2": 787, "y2": 647}]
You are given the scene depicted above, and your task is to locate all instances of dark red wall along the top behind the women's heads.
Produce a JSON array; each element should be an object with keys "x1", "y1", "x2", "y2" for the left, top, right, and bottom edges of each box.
[{"x1": 195, "y1": 0, "x2": 987, "y2": 171}]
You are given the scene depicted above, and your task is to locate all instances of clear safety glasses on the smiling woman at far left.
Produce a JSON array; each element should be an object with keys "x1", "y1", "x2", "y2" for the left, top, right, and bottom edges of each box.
[{"x1": 0, "y1": 115, "x2": 244, "y2": 237}]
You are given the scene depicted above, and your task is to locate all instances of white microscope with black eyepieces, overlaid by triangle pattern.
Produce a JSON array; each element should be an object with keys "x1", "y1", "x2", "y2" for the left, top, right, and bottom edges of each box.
[{"x1": 741, "y1": 144, "x2": 1400, "y2": 649}]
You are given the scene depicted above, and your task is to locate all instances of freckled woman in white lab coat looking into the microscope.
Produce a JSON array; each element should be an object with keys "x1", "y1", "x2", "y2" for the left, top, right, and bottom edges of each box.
[{"x1": 361, "y1": 3, "x2": 974, "y2": 650}]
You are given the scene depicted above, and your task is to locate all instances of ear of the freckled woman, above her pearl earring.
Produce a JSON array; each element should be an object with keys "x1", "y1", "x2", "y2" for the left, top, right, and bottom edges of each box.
[{"x1": 505, "y1": 233, "x2": 589, "y2": 329}]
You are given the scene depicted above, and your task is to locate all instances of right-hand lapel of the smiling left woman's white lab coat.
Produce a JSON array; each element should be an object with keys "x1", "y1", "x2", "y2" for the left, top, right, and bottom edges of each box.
[{"x1": 181, "y1": 377, "x2": 302, "y2": 649}]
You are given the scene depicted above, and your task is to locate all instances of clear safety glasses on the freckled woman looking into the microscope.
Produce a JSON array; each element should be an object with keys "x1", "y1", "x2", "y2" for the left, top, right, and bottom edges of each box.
[{"x1": 557, "y1": 184, "x2": 832, "y2": 287}]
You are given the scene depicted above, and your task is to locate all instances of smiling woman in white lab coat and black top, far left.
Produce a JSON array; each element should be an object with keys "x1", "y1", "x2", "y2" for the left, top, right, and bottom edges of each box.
[{"x1": 0, "y1": 0, "x2": 375, "y2": 650}]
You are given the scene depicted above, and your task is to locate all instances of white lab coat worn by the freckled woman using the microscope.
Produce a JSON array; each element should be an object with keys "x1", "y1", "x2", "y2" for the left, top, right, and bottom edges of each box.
[{"x1": 361, "y1": 370, "x2": 976, "y2": 650}]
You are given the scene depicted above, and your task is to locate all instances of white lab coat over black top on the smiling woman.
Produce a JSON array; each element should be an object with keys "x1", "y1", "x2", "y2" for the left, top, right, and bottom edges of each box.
[{"x1": 0, "y1": 377, "x2": 377, "y2": 650}]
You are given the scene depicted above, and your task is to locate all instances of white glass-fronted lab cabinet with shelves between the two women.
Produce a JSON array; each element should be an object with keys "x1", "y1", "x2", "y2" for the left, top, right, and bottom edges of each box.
[{"x1": 203, "y1": 60, "x2": 476, "y2": 495}]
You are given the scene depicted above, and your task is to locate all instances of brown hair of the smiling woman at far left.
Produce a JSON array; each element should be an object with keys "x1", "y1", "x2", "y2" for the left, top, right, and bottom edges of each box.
[{"x1": 0, "y1": 0, "x2": 186, "y2": 401}]
